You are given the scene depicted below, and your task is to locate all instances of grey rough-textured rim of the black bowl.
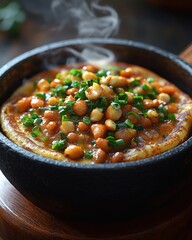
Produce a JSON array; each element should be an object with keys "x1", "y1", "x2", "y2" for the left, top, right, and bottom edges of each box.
[{"x1": 0, "y1": 38, "x2": 192, "y2": 171}]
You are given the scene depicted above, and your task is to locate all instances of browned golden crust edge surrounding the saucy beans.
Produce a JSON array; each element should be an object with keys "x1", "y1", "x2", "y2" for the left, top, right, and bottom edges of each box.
[{"x1": 1, "y1": 67, "x2": 192, "y2": 162}]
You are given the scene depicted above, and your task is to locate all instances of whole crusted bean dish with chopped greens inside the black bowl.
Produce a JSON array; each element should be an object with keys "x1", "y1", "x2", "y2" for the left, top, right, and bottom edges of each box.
[{"x1": 1, "y1": 63, "x2": 192, "y2": 164}]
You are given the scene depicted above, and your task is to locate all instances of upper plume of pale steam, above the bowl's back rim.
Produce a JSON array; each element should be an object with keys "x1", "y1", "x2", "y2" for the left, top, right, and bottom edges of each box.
[{"x1": 52, "y1": 0, "x2": 119, "y2": 37}]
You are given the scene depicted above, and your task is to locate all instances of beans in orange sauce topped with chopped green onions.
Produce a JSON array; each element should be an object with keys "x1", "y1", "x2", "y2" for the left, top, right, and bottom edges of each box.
[{"x1": 15, "y1": 65, "x2": 181, "y2": 163}]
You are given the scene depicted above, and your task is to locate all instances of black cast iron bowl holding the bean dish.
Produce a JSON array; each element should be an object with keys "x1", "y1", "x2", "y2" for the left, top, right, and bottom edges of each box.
[{"x1": 0, "y1": 39, "x2": 192, "y2": 220}]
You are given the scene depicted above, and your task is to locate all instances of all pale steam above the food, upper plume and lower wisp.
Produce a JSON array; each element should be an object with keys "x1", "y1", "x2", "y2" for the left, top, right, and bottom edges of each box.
[{"x1": 22, "y1": 0, "x2": 119, "y2": 63}]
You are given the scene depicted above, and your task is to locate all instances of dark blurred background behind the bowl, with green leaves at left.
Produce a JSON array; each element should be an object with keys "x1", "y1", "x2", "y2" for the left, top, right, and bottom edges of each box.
[{"x1": 0, "y1": 0, "x2": 192, "y2": 66}]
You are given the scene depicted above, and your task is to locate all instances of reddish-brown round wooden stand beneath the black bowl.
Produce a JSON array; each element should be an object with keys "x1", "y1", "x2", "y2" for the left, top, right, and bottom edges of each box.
[{"x1": 0, "y1": 172, "x2": 192, "y2": 240}]
